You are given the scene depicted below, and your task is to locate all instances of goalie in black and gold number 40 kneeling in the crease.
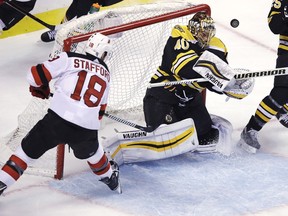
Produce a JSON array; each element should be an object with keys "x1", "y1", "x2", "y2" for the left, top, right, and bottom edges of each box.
[{"x1": 105, "y1": 12, "x2": 254, "y2": 164}]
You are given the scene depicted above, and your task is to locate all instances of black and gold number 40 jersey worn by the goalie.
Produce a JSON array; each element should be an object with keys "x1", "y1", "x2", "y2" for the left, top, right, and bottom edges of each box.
[{"x1": 150, "y1": 25, "x2": 227, "y2": 101}]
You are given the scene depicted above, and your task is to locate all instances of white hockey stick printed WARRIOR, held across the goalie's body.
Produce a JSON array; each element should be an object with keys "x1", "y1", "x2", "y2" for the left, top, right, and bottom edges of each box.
[{"x1": 148, "y1": 67, "x2": 288, "y2": 88}]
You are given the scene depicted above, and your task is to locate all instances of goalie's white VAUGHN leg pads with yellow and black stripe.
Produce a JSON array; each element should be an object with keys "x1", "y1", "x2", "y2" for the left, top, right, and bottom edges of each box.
[{"x1": 102, "y1": 115, "x2": 232, "y2": 165}]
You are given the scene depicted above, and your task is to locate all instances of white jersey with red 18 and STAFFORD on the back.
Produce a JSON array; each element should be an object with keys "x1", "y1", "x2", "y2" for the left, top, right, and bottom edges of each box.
[{"x1": 27, "y1": 52, "x2": 110, "y2": 130}]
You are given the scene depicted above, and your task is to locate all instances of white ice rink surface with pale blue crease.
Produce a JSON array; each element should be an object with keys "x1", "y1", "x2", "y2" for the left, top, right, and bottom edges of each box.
[{"x1": 0, "y1": 0, "x2": 288, "y2": 216}]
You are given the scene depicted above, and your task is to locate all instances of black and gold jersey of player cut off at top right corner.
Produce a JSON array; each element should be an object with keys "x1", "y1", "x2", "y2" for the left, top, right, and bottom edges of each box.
[{"x1": 268, "y1": 0, "x2": 288, "y2": 55}]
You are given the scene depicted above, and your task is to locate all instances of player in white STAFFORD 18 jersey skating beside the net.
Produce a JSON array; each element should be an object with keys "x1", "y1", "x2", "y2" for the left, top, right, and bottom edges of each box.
[{"x1": 0, "y1": 33, "x2": 121, "y2": 194}]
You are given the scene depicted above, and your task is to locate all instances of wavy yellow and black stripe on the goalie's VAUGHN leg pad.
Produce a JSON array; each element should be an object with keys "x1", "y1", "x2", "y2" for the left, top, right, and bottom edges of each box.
[{"x1": 111, "y1": 127, "x2": 195, "y2": 158}]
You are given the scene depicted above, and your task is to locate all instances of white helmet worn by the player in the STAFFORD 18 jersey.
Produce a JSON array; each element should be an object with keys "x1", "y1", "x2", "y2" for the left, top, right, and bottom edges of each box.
[{"x1": 85, "y1": 33, "x2": 112, "y2": 61}]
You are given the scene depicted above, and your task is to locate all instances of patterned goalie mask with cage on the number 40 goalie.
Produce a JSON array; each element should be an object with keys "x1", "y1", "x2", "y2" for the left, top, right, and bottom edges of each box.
[{"x1": 188, "y1": 12, "x2": 216, "y2": 49}]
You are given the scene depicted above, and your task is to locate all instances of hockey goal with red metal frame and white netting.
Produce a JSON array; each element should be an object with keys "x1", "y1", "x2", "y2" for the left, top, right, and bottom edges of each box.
[{"x1": 2, "y1": 1, "x2": 210, "y2": 179}]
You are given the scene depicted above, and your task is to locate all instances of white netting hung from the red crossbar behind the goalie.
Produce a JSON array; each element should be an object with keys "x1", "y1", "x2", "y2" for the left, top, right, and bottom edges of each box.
[{"x1": 51, "y1": 2, "x2": 200, "y2": 113}]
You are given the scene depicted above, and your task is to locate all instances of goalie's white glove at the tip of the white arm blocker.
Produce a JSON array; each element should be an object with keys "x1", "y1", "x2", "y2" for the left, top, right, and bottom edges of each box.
[{"x1": 223, "y1": 78, "x2": 255, "y2": 99}]
